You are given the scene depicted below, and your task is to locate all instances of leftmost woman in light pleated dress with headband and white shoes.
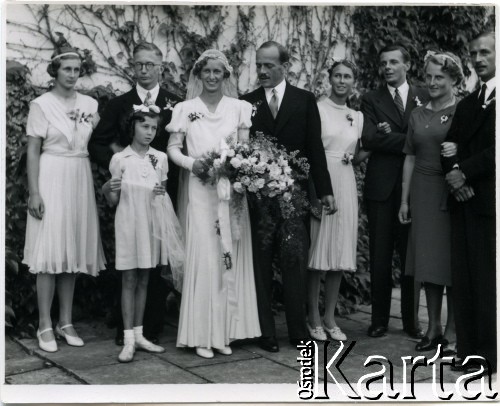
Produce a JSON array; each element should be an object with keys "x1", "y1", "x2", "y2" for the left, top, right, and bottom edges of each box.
[{"x1": 23, "y1": 47, "x2": 105, "y2": 352}]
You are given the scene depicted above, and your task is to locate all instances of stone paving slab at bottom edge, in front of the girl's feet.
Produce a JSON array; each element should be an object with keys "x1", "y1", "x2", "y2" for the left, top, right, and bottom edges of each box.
[{"x1": 78, "y1": 357, "x2": 208, "y2": 385}]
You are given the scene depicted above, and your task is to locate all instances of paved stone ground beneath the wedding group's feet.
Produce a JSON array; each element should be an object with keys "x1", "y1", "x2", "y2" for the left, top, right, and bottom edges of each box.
[{"x1": 5, "y1": 289, "x2": 492, "y2": 400}]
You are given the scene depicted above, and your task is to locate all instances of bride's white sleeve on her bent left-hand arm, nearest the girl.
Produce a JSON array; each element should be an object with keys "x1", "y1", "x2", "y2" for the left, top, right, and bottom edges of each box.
[{"x1": 166, "y1": 103, "x2": 195, "y2": 171}]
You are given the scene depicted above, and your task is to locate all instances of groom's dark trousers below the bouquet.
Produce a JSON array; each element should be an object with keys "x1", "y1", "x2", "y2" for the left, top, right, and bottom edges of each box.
[{"x1": 250, "y1": 205, "x2": 310, "y2": 339}]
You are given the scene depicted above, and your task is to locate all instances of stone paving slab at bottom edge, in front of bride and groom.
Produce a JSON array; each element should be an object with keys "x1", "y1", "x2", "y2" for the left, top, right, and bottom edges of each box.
[{"x1": 190, "y1": 358, "x2": 298, "y2": 384}]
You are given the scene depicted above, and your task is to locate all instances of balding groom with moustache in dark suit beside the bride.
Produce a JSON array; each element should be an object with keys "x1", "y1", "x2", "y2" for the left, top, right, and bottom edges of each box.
[{"x1": 241, "y1": 41, "x2": 336, "y2": 352}]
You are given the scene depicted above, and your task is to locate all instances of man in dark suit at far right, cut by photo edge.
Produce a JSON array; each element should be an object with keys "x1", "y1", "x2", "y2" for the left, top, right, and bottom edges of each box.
[{"x1": 442, "y1": 33, "x2": 497, "y2": 371}]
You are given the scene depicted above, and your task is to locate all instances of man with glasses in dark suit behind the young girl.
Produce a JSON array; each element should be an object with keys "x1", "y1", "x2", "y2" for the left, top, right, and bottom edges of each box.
[{"x1": 88, "y1": 42, "x2": 180, "y2": 345}]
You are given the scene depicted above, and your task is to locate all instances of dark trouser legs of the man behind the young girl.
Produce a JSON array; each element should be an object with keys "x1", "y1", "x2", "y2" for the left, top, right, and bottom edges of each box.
[{"x1": 115, "y1": 267, "x2": 168, "y2": 338}]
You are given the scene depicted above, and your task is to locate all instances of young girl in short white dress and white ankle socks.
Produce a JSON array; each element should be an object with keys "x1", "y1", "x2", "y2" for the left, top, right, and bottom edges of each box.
[{"x1": 103, "y1": 105, "x2": 184, "y2": 362}]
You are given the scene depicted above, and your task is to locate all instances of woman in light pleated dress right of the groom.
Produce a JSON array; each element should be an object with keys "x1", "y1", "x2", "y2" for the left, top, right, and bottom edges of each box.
[{"x1": 307, "y1": 60, "x2": 368, "y2": 340}]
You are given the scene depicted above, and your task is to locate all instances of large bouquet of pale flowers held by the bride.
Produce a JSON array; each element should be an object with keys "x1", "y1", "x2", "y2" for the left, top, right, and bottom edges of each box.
[{"x1": 194, "y1": 132, "x2": 309, "y2": 219}]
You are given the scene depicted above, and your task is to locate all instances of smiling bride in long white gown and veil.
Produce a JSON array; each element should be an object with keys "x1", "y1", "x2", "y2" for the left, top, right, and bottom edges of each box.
[{"x1": 167, "y1": 50, "x2": 261, "y2": 358}]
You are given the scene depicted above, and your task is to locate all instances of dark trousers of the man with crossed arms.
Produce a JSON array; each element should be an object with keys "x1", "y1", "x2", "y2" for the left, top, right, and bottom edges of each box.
[{"x1": 365, "y1": 187, "x2": 420, "y2": 330}]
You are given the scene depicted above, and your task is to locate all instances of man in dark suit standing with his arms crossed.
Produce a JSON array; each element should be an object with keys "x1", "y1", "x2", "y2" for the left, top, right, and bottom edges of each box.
[{"x1": 361, "y1": 45, "x2": 427, "y2": 338}]
